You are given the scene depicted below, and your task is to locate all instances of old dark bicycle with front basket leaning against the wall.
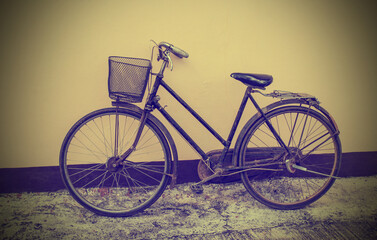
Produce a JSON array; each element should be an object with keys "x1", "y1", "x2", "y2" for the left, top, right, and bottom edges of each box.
[{"x1": 60, "y1": 42, "x2": 342, "y2": 217}]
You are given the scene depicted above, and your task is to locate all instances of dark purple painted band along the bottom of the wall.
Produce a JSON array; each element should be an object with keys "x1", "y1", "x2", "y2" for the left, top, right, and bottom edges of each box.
[{"x1": 0, "y1": 152, "x2": 377, "y2": 193}]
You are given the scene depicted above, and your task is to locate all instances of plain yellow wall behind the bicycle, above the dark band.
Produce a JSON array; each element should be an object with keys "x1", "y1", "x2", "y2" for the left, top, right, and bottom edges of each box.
[{"x1": 0, "y1": 0, "x2": 377, "y2": 168}]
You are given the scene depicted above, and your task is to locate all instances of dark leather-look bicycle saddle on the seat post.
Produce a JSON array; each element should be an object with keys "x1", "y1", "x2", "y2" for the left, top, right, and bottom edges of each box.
[{"x1": 230, "y1": 73, "x2": 273, "y2": 89}]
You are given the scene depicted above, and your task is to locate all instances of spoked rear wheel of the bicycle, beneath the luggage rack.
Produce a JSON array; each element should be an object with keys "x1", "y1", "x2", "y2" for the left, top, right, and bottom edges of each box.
[{"x1": 240, "y1": 106, "x2": 341, "y2": 209}]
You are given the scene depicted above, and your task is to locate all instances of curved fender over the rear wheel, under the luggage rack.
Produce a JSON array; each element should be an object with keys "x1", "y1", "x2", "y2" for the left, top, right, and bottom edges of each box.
[{"x1": 232, "y1": 98, "x2": 339, "y2": 166}]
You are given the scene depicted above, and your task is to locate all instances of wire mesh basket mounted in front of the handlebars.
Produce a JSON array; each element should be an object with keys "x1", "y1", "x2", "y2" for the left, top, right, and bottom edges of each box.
[{"x1": 109, "y1": 56, "x2": 152, "y2": 103}]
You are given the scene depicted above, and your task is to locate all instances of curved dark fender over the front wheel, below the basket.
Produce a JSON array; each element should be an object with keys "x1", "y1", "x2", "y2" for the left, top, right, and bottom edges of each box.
[{"x1": 111, "y1": 101, "x2": 178, "y2": 188}]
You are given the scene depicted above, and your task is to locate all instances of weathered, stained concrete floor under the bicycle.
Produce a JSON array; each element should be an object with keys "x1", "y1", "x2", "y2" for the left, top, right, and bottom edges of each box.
[{"x1": 0, "y1": 176, "x2": 377, "y2": 239}]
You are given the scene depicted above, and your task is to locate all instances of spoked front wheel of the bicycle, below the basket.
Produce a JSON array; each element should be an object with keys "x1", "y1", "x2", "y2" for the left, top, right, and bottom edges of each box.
[{"x1": 60, "y1": 108, "x2": 171, "y2": 216}]
